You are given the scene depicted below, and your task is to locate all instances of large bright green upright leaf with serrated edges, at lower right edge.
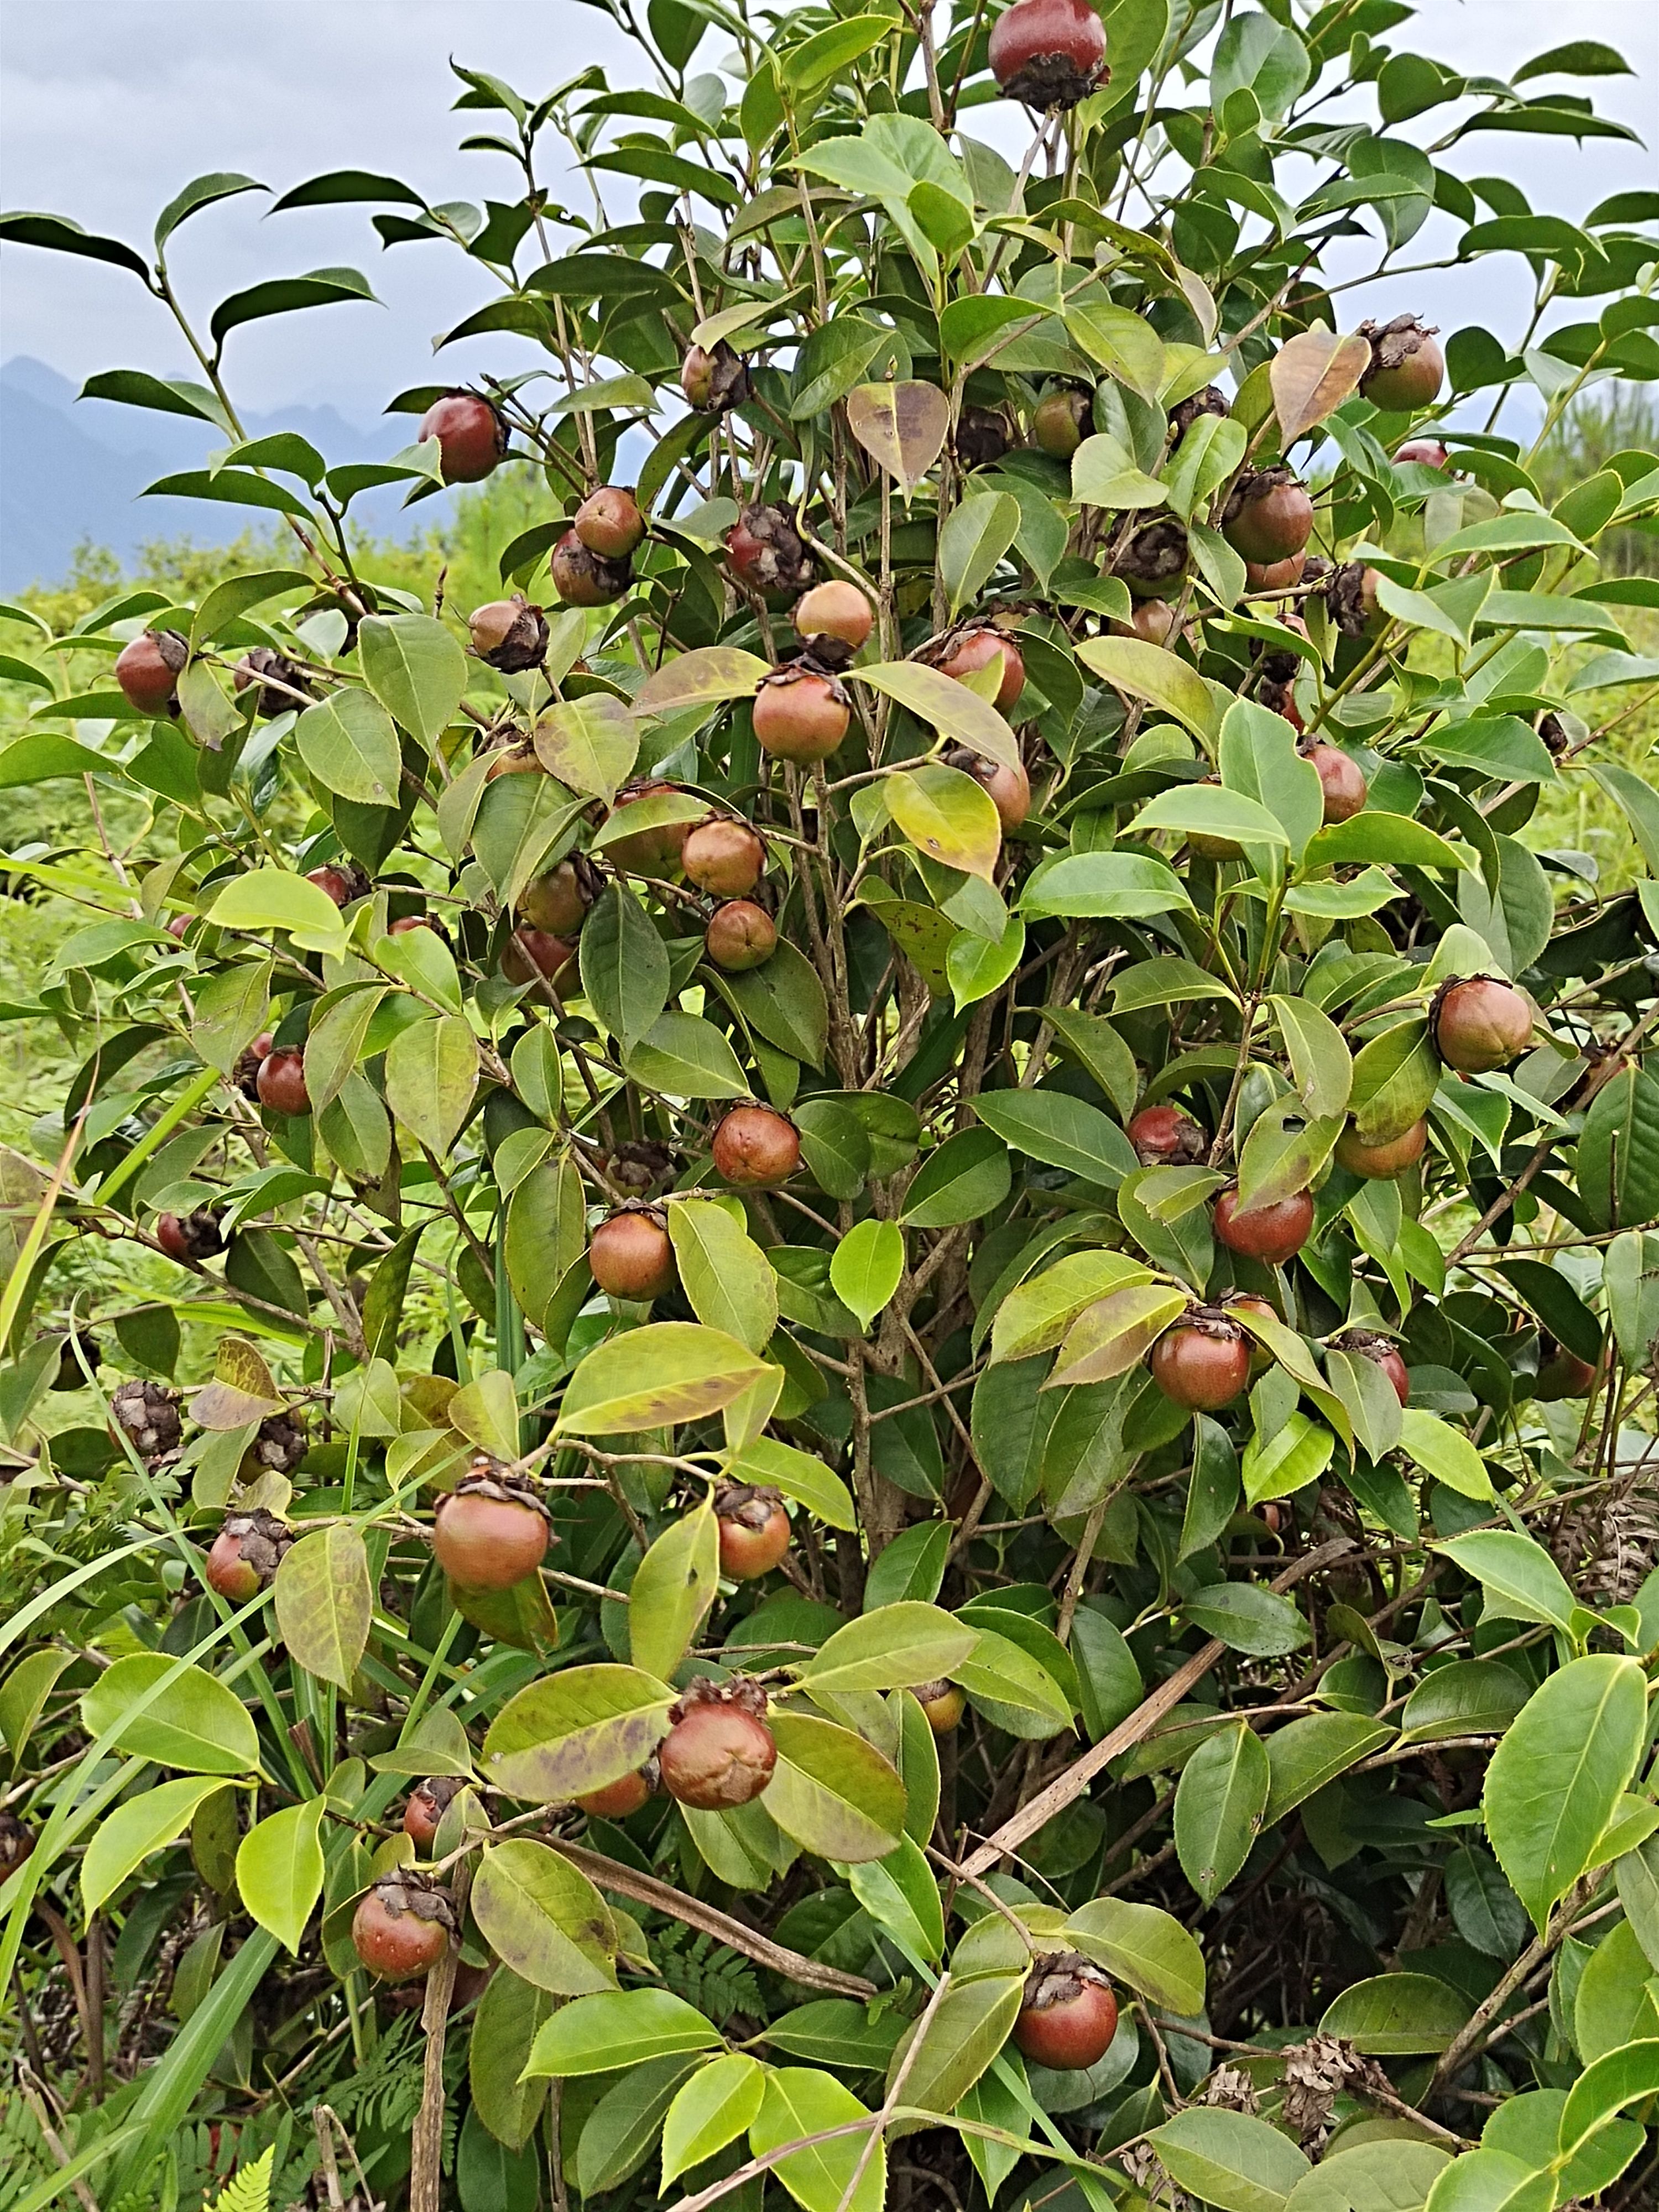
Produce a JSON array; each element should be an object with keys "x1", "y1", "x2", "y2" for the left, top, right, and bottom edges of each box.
[{"x1": 1462, "y1": 1655, "x2": 1646, "y2": 1933}]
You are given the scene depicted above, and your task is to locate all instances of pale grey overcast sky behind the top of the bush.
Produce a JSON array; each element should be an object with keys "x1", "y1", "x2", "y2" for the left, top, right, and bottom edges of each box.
[{"x1": 0, "y1": 0, "x2": 1659, "y2": 420}]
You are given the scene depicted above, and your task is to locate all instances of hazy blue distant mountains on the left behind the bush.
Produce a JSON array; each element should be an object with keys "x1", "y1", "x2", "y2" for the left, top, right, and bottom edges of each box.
[{"x1": 0, "y1": 354, "x2": 440, "y2": 591}]
